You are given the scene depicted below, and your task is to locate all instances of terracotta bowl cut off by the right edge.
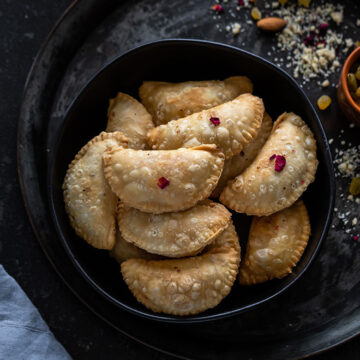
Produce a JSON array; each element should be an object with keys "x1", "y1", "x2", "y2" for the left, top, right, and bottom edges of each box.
[{"x1": 337, "y1": 47, "x2": 360, "y2": 126}]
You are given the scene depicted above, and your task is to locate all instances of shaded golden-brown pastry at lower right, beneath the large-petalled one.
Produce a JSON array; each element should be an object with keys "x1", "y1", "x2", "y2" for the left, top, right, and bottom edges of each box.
[{"x1": 239, "y1": 200, "x2": 310, "y2": 285}]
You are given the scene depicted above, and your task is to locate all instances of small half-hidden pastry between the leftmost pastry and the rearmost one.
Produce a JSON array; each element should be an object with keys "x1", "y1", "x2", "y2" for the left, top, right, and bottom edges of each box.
[{"x1": 106, "y1": 92, "x2": 154, "y2": 150}]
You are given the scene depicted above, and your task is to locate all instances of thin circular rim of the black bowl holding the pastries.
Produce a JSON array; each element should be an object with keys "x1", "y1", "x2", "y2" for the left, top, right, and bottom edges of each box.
[{"x1": 47, "y1": 38, "x2": 335, "y2": 324}]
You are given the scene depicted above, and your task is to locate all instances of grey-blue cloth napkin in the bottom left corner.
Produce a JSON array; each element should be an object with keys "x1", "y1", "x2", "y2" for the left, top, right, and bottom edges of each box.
[{"x1": 0, "y1": 265, "x2": 71, "y2": 360}]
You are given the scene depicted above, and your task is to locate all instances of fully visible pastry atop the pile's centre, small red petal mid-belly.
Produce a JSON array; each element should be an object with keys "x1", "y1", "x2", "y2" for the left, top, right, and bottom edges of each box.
[{"x1": 103, "y1": 145, "x2": 224, "y2": 214}]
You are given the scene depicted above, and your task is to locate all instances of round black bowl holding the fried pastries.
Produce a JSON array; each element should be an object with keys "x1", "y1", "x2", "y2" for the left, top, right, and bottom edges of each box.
[{"x1": 48, "y1": 39, "x2": 335, "y2": 322}]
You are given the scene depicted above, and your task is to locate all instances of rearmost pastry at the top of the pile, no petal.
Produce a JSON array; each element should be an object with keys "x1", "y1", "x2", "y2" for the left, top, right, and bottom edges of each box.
[{"x1": 139, "y1": 76, "x2": 253, "y2": 126}]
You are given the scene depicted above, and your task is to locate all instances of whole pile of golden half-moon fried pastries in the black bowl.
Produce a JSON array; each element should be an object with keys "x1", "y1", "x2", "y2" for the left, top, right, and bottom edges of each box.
[{"x1": 63, "y1": 76, "x2": 317, "y2": 315}]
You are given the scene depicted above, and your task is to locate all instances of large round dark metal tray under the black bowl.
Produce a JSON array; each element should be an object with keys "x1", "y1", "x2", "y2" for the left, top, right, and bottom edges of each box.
[{"x1": 18, "y1": 0, "x2": 360, "y2": 359}]
